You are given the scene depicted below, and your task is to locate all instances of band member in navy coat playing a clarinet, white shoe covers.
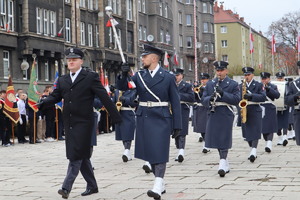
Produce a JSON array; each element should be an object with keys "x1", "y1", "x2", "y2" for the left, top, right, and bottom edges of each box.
[{"x1": 202, "y1": 61, "x2": 240, "y2": 177}]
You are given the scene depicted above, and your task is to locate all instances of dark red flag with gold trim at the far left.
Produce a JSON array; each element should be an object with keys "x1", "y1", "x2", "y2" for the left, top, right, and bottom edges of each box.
[{"x1": 3, "y1": 76, "x2": 20, "y2": 124}]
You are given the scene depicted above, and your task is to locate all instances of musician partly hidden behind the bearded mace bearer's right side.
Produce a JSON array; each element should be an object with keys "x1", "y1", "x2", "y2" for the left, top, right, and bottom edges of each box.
[{"x1": 175, "y1": 68, "x2": 195, "y2": 163}]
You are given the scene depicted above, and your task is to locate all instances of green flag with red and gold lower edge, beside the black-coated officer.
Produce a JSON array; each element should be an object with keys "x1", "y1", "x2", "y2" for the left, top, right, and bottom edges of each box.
[{"x1": 28, "y1": 60, "x2": 40, "y2": 112}]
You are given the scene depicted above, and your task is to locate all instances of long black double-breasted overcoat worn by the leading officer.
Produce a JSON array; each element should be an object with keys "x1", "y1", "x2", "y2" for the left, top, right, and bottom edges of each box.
[{"x1": 43, "y1": 69, "x2": 121, "y2": 161}]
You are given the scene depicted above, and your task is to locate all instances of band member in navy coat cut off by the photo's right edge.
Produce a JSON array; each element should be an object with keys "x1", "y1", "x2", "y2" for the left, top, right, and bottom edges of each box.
[{"x1": 285, "y1": 61, "x2": 300, "y2": 146}]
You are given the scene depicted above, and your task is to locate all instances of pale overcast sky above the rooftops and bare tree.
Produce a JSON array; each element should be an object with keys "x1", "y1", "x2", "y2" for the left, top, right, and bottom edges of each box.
[{"x1": 218, "y1": 0, "x2": 300, "y2": 35}]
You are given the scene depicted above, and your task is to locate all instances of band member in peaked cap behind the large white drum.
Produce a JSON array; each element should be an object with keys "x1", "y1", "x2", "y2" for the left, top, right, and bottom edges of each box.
[{"x1": 274, "y1": 72, "x2": 290, "y2": 146}]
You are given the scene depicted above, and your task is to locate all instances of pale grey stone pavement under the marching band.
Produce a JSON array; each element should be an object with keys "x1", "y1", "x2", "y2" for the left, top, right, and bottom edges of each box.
[{"x1": 0, "y1": 125, "x2": 300, "y2": 200}]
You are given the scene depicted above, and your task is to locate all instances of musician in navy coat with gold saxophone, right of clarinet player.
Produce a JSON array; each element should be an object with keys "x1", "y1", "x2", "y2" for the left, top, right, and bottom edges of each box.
[{"x1": 240, "y1": 67, "x2": 266, "y2": 162}]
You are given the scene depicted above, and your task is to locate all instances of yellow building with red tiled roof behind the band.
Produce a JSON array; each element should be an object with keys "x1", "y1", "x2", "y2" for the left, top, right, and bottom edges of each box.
[{"x1": 214, "y1": 2, "x2": 272, "y2": 74}]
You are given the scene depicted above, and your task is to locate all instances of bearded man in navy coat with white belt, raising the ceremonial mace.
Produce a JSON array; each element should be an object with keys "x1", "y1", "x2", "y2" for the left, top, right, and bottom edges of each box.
[{"x1": 118, "y1": 44, "x2": 182, "y2": 199}]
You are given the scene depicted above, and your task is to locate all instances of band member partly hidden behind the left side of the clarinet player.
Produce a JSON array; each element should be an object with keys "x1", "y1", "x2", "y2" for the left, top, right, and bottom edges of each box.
[{"x1": 194, "y1": 73, "x2": 210, "y2": 153}]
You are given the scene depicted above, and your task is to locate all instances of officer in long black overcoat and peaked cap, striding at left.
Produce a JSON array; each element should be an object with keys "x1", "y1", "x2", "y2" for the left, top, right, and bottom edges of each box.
[{"x1": 40, "y1": 48, "x2": 121, "y2": 199}]
